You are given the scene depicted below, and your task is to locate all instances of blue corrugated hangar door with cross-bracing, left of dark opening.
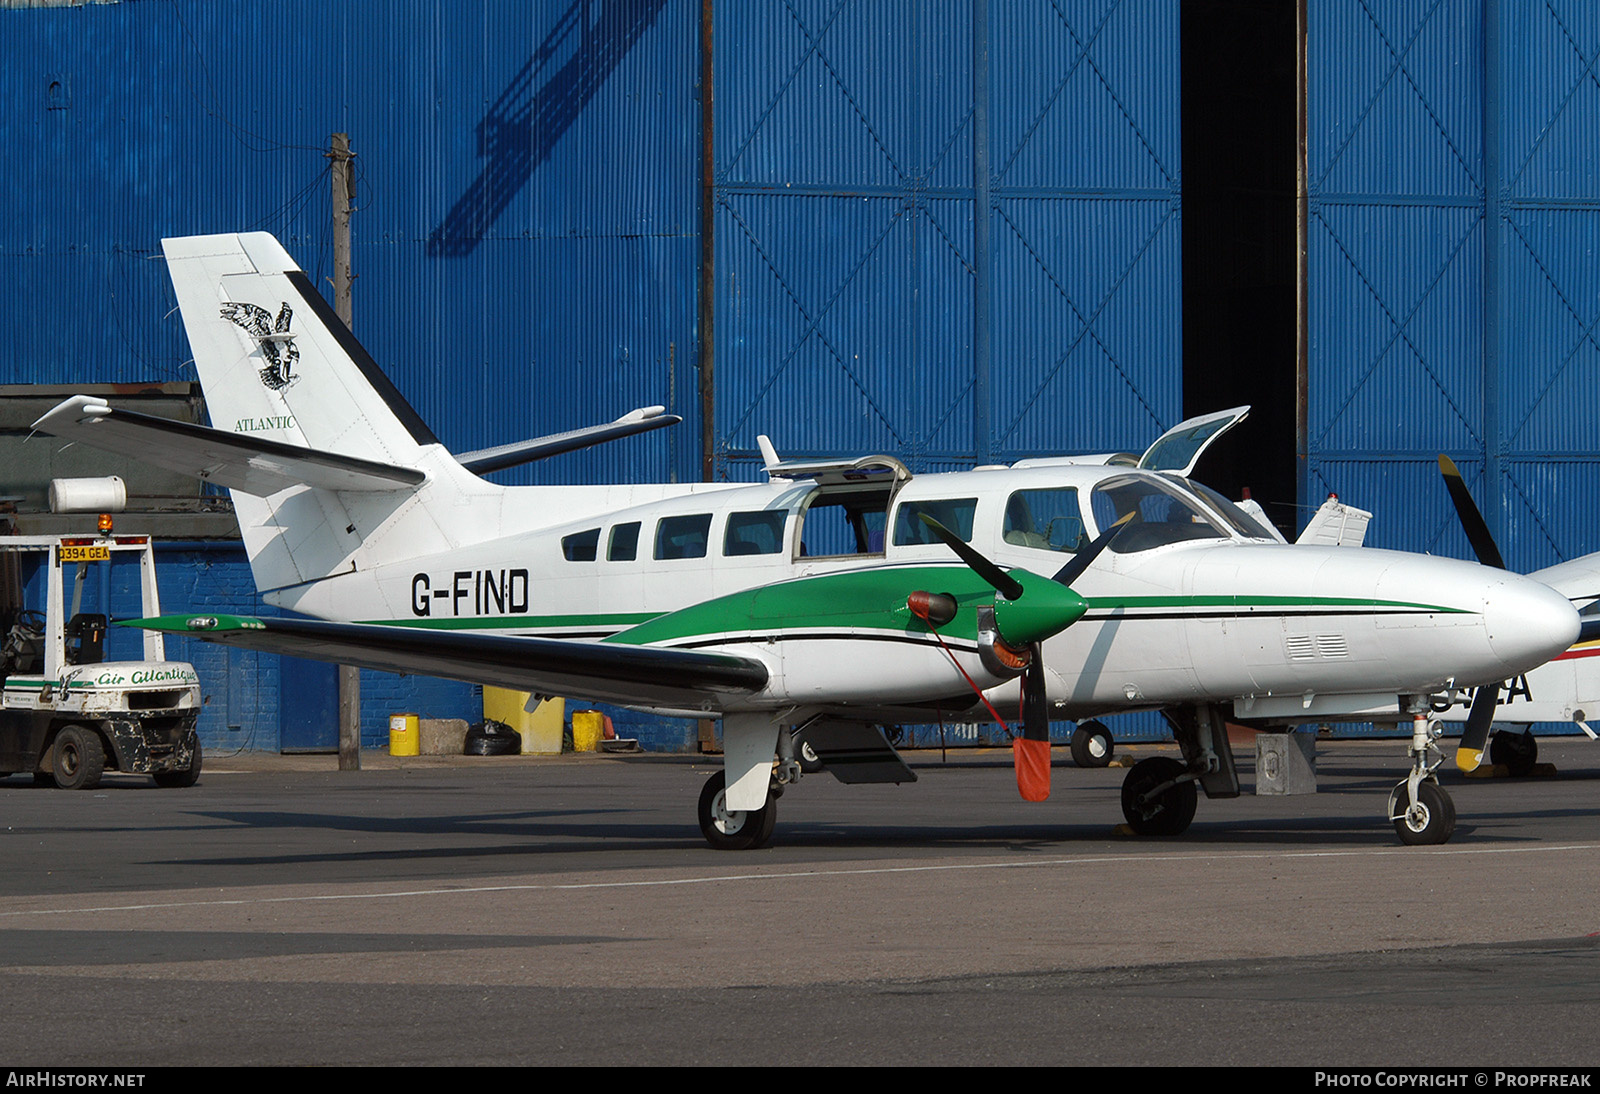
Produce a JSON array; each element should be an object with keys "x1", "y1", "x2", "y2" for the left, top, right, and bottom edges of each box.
[{"x1": 714, "y1": 0, "x2": 1182, "y2": 478}]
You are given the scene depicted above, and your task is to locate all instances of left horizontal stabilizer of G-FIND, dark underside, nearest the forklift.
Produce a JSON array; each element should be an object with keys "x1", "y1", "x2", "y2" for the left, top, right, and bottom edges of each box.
[{"x1": 34, "y1": 395, "x2": 426, "y2": 497}]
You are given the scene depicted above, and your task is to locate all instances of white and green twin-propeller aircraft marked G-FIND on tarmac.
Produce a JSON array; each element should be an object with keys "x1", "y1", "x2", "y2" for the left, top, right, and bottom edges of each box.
[{"x1": 37, "y1": 234, "x2": 1579, "y2": 848}]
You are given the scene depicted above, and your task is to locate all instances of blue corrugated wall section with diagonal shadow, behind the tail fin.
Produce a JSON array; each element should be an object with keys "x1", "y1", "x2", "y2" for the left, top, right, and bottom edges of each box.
[{"x1": 0, "y1": 0, "x2": 699, "y2": 481}]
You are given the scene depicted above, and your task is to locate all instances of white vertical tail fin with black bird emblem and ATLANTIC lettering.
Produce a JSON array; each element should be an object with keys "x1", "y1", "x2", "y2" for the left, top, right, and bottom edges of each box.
[{"x1": 158, "y1": 232, "x2": 501, "y2": 606}]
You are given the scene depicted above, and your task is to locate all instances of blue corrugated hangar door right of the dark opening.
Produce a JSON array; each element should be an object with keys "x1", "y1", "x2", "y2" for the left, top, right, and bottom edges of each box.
[{"x1": 1301, "y1": 0, "x2": 1600, "y2": 569}]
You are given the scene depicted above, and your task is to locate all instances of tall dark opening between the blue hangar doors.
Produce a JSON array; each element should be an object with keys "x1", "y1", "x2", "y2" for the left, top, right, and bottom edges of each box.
[{"x1": 1179, "y1": 0, "x2": 1315, "y2": 539}]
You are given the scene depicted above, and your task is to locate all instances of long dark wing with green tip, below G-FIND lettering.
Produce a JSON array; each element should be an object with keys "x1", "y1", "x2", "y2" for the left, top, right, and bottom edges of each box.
[{"x1": 118, "y1": 616, "x2": 768, "y2": 710}]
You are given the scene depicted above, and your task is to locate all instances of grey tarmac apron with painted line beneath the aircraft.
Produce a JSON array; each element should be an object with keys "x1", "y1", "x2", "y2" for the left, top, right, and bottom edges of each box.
[{"x1": 0, "y1": 739, "x2": 1600, "y2": 1068}]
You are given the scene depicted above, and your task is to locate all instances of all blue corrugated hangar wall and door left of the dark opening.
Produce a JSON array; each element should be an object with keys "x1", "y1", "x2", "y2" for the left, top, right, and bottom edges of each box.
[{"x1": 0, "y1": 0, "x2": 1182, "y2": 745}]
